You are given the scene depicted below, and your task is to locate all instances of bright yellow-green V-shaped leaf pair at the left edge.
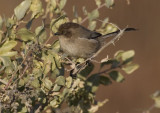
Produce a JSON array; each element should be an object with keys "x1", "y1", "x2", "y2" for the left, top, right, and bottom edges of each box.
[{"x1": 0, "y1": 40, "x2": 17, "y2": 57}]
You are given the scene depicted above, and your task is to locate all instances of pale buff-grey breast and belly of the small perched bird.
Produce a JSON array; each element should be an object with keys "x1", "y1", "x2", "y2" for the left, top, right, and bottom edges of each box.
[{"x1": 59, "y1": 37, "x2": 99, "y2": 58}]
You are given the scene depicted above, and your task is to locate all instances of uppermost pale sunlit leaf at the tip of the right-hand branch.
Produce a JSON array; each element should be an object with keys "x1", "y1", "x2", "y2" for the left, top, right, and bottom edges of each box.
[{"x1": 121, "y1": 50, "x2": 135, "y2": 61}]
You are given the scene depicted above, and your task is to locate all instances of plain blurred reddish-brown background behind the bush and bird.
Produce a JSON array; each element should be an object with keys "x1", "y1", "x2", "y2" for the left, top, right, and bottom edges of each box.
[{"x1": 0, "y1": 0, "x2": 160, "y2": 113}]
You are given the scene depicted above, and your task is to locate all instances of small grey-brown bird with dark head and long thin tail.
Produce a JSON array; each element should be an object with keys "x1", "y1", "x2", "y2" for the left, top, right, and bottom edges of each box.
[{"x1": 55, "y1": 22, "x2": 135, "y2": 58}]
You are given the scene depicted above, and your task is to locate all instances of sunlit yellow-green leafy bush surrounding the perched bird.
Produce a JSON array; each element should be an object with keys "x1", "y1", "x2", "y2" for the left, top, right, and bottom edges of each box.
[{"x1": 0, "y1": 0, "x2": 139, "y2": 113}]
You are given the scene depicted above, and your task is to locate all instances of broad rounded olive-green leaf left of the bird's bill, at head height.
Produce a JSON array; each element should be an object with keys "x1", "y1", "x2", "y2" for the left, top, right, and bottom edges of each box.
[{"x1": 18, "y1": 28, "x2": 35, "y2": 41}]
